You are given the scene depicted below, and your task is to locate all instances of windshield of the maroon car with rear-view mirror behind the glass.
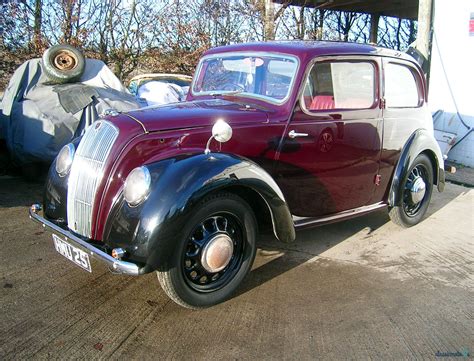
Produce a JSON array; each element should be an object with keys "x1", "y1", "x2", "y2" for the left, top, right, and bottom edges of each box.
[{"x1": 192, "y1": 53, "x2": 298, "y2": 103}]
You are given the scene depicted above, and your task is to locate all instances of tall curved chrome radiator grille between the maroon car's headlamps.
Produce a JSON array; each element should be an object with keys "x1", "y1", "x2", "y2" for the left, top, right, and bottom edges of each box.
[{"x1": 67, "y1": 120, "x2": 119, "y2": 237}]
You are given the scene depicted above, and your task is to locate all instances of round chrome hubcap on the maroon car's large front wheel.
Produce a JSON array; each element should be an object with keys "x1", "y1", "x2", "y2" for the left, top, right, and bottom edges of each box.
[{"x1": 201, "y1": 234, "x2": 234, "y2": 273}]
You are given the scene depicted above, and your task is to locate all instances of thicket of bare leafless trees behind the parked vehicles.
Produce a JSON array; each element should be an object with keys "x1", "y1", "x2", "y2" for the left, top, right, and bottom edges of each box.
[{"x1": 0, "y1": 0, "x2": 416, "y2": 87}]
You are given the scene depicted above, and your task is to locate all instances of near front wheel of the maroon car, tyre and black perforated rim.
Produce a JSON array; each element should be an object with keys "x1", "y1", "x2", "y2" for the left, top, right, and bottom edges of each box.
[{"x1": 157, "y1": 193, "x2": 257, "y2": 309}]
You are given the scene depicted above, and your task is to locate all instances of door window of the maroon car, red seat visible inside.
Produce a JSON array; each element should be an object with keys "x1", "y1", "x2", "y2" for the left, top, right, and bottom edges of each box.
[{"x1": 303, "y1": 61, "x2": 375, "y2": 111}]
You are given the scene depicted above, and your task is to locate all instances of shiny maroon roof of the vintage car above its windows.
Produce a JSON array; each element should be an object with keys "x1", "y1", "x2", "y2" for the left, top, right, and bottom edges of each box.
[{"x1": 204, "y1": 40, "x2": 417, "y2": 64}]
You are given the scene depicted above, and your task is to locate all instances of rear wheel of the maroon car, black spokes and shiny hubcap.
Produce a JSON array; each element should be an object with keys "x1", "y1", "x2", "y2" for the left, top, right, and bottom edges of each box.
[{"x1": 389, "y1": 154, "x2": 433, "y2": 227}]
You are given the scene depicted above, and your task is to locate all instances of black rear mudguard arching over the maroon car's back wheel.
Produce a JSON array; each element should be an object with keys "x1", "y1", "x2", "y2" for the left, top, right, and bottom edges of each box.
[{"x1": 388, "y1": 129, "x2": 445, "y2": 207}]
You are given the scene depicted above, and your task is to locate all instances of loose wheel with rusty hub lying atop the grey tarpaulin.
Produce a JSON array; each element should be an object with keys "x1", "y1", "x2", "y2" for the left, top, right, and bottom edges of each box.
[{"x1": 41, "y1": 45, "x2": 86, "y2": 84}]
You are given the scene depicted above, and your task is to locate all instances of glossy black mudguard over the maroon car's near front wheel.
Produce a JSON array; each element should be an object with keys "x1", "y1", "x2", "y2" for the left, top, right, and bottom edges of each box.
[{"x1": 104, "y1": 153, "x2": 296, "y2": 271}]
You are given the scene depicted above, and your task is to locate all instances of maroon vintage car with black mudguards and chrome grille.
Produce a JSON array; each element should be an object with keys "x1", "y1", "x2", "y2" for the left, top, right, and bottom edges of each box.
[{"x1": 30, "y1": 42, "x2": 445, "y2": 308}]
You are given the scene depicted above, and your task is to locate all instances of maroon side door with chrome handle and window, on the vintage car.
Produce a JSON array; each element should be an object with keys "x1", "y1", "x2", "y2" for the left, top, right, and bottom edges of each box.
[{"x1": 276, "y1": 56, "x2": 382, "y2": 217}]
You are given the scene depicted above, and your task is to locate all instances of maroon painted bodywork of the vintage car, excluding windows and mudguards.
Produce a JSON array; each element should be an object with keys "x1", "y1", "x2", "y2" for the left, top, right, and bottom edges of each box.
[{"x1": 92, "y1": 42, "x2": 427, "y2": 239}]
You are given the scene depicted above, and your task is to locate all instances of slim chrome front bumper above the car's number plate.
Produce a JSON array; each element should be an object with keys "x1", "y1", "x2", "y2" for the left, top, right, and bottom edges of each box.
[{"x1": 30, "y1": 204, "x2": 144, "y2": 276}]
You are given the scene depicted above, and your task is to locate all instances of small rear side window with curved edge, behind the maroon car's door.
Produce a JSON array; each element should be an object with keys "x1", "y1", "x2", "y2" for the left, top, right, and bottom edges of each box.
[{"x1": 385, "y1": 63, "x2": 420, "y2": 108}]
